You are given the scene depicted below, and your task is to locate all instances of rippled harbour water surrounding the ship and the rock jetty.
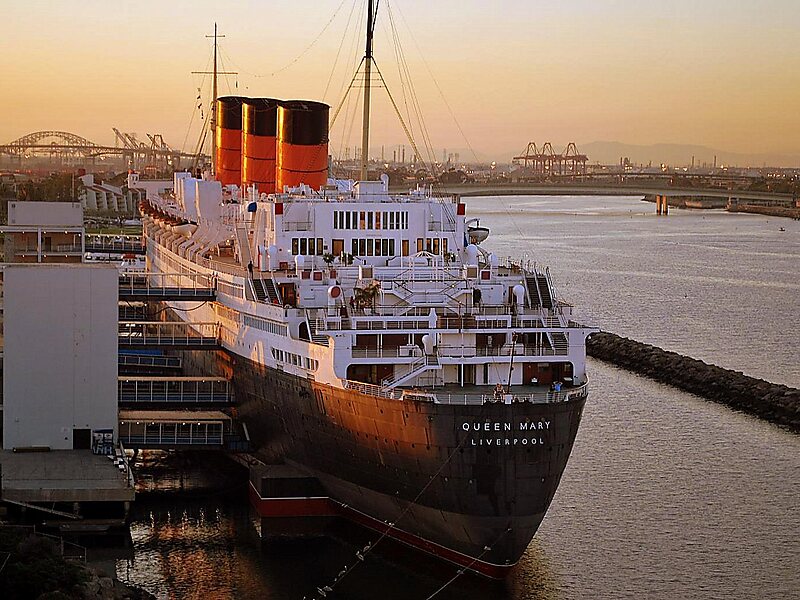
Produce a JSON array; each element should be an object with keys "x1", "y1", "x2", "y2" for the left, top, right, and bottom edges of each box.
[{"x1": 112, "y1": 197, "x2": 800, "y2": 600}]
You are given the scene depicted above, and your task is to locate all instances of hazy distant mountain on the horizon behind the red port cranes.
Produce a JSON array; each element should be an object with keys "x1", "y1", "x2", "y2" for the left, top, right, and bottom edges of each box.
[{"x1": 578, "y1": 142, "x2": 800, "y2": 167}]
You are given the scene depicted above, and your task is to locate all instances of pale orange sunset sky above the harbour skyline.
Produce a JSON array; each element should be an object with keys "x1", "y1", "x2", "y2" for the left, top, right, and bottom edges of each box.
[{"x1": 0, "y1": 0, "x2": 800, "y2": 160}]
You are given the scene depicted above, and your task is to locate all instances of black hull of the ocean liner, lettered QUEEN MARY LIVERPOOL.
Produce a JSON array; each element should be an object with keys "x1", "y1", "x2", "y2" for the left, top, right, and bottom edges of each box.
[{"x1": 232, "y1": 356, "x2": 586, "y2": 577}]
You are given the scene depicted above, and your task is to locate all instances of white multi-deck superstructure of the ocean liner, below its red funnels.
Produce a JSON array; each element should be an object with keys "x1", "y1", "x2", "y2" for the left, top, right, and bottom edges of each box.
[{"x1": 134, "y1": 173, "x2": 593, "y2": 403}]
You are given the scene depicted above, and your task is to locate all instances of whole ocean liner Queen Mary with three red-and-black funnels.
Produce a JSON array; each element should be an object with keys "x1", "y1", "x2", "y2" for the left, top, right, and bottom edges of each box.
[{"x1": 128, "y1": 2, "x2": 594, "y2": 577}]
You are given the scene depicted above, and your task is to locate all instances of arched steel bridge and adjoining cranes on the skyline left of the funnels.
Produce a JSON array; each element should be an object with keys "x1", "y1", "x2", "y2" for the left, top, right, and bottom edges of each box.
[{"x1": 0, "y1": 128, "x2": 206, "y2": 171}]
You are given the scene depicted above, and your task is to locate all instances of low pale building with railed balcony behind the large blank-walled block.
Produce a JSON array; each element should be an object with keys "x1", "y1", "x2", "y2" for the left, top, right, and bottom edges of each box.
[{"x1": 0, "y1": 202, "x2": 84, "y2": 263}]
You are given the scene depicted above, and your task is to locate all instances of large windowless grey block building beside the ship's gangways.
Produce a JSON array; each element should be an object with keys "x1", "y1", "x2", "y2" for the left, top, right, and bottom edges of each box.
[{"x1": 3, "y1": 264, "x2": 119, "y2": 450}]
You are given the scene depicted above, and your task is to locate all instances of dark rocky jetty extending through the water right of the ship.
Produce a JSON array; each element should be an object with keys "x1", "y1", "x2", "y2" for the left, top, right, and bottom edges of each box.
[{"x1": 586, "y1": 332, "x2": 800, "y2": 432}]
